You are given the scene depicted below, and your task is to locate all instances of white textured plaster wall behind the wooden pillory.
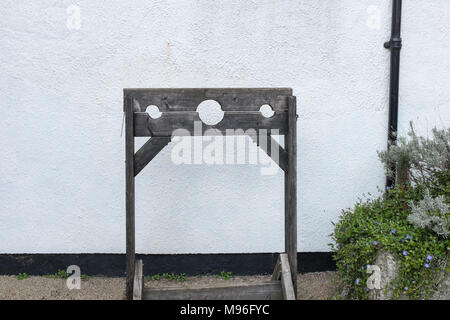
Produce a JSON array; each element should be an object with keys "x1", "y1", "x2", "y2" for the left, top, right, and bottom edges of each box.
[{"x1": 0, "y1": 0, "x2": 450, "y2": 253}]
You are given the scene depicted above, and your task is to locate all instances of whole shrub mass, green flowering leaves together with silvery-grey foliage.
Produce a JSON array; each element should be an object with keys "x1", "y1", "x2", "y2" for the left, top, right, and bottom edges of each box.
[{"x1": 330, "y1": 126, "x2": 450, "y2": 299}]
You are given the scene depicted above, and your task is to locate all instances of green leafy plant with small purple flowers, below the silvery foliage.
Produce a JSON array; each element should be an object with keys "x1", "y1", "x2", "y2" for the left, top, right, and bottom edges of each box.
[{"x1": 330, "y1": 182, "x2": 450, "y2": 299}]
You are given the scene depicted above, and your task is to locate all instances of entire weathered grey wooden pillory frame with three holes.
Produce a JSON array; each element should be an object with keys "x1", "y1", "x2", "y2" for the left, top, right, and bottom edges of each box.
[{"x1": 124, "y1": 88, "x2": 297, "y2": 299}]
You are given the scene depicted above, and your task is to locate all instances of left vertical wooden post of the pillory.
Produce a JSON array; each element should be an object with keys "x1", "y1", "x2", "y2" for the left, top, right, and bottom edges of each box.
[{"x1": 124, "y1": 97, "x2": 135, "y2": 300}]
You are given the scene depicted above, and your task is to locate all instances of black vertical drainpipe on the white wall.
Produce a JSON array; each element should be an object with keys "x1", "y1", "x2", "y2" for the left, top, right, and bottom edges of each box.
[{"x1": 384, "y1": 0, "x2": 402, "y2": 187}]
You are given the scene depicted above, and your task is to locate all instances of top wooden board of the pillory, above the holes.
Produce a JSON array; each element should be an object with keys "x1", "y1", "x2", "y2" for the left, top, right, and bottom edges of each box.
[{"x1": 124, "y1": 88, "x2": 292, "y2": 112}]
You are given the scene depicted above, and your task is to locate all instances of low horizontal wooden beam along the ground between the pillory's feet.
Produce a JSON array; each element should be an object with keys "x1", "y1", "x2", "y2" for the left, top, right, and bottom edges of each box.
[{"x1": 143, "y1": 281, "x2": 283, "y2": 300}]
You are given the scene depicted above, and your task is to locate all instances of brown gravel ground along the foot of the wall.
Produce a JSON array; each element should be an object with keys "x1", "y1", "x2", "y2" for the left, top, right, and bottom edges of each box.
[{"x1": 0, "y1": 272, "x2": 338, "y2": 300}]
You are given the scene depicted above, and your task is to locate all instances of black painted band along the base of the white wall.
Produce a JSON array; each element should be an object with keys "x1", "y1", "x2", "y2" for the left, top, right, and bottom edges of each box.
[{"x1": 0, "y1": 252, "x2": 336, "y2": 277}]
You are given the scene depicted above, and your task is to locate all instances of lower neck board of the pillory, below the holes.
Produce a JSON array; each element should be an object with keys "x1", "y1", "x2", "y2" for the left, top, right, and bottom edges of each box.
[{"x1": 134, "y1": 111, "x2": 288, "y2": 137}]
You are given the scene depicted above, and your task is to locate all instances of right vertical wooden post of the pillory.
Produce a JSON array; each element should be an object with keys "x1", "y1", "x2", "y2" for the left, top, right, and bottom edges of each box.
[{"x1": 284, "y1": 96, "x2": 297, "y2": 296}]
